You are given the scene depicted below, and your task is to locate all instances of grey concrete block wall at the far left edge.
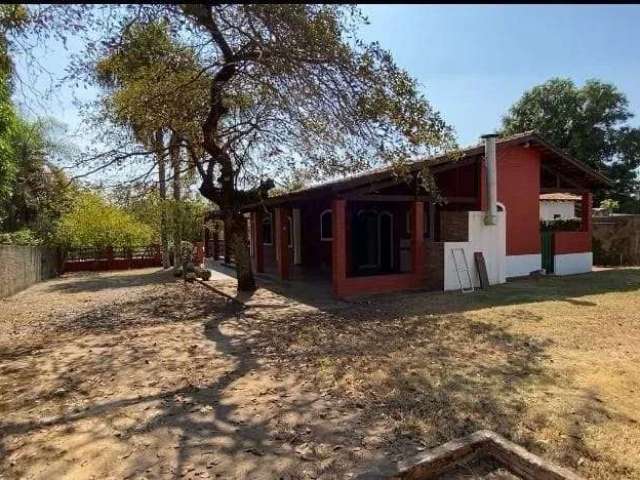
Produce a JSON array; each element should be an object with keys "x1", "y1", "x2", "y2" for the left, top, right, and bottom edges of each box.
[{"x1": 0, "y1": 245, "x2": 58, "y2": 298}]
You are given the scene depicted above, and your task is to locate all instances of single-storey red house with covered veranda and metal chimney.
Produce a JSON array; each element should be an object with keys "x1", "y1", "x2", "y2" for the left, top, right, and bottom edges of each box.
[{"x1": 240, "y1": 132, "x2": 610, "y2": 297}]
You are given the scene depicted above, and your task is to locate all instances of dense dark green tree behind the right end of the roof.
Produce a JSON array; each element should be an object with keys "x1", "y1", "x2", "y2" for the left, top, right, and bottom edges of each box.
[{"x1": 503, "y1": 78, "x2": 640, "y2": 206}]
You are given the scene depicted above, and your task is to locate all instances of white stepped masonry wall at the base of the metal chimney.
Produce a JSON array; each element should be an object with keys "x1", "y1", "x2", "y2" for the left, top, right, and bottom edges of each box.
[{"x1": 444, "y1": 211, "x2": 507, "y2": 290}]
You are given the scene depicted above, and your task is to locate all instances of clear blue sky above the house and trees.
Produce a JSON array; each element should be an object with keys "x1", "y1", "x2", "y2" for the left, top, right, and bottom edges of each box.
[{"x1": 12, "y1": 5, "x2": 640, "y2": 153}]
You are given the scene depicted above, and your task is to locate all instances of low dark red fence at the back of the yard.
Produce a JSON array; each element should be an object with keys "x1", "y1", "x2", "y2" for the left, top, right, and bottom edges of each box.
[{"x1": 63, "y1": 245, "x2": 162, "y2": 272}]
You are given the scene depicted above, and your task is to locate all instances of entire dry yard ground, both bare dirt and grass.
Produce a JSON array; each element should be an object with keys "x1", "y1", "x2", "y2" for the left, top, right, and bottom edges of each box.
[{"x1": 0, "y1": 269, "x2": 640, "y2": 479}]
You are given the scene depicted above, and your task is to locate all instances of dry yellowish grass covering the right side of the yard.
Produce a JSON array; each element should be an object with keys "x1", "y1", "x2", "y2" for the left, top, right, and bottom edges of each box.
[{"x1": 245, "y1": 269, "x2": 640, "y2": 479}]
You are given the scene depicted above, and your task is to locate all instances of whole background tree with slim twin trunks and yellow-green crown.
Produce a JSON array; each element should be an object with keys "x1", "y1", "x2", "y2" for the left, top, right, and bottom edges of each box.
[{"x1": 96, "y1": 21, "x2": 208, "y2": 267}]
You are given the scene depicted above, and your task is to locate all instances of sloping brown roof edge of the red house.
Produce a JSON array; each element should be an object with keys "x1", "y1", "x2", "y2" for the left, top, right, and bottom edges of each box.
[{"x1": 244, "y1": 131, "x2": 612, "y2": 209}]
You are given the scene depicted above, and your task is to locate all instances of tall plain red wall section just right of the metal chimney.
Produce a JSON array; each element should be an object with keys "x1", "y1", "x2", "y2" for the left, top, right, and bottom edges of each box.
[{"x1": 497, "y1": 146, "x2": 540, "y2": 255}]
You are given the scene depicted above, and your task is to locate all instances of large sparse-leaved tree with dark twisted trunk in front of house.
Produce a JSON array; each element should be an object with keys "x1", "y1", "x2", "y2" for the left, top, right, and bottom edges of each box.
[{"x1": 65, "y1": 4, "x2": 453, "y2": 290}]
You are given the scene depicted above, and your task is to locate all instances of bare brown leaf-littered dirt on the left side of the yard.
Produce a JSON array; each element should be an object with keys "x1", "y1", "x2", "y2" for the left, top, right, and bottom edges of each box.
[{"x1": 0, "y1": 270, "x2": 392, "y2": 479}]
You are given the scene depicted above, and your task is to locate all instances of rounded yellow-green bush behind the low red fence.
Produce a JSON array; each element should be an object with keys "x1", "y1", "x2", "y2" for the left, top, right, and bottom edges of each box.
[{"x1": 55, "y1": 192, "x2": 153, "y2": 249}]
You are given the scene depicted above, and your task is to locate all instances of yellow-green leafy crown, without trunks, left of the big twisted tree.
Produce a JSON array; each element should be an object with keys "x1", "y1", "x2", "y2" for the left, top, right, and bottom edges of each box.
[{"x1": 95, "y1": 21, "x2": 209, "y2": 143}]
